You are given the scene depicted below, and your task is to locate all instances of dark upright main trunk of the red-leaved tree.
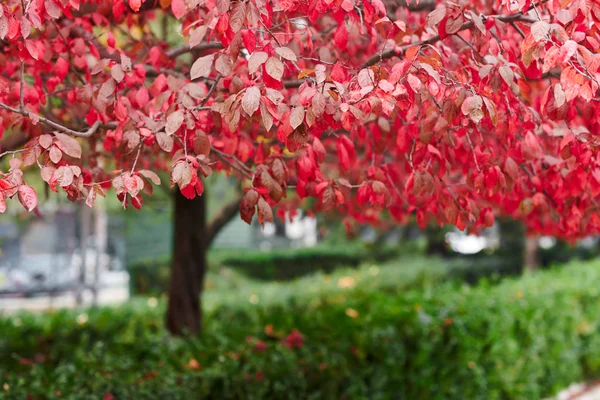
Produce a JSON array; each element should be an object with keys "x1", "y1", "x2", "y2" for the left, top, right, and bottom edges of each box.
[{"x1": 166, "y1": 190, "x2": 208, "y2": 335}]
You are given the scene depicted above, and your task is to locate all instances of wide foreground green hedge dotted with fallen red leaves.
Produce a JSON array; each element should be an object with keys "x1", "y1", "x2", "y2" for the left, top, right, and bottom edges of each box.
[{"x1": 0, "y1": 262, "x2": 600, "y2": 399}]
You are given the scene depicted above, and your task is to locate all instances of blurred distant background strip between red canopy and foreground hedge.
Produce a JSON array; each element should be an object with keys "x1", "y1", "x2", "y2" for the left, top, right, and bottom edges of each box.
[{"x1": 0, "y1": 173, "x2": 600, "y2": 313}]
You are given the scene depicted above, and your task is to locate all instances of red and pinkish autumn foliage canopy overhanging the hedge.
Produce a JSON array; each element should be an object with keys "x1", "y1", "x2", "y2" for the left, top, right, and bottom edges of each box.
[{"x1": 0, "y1": 0, "x2": 600, "y2": 238}]
